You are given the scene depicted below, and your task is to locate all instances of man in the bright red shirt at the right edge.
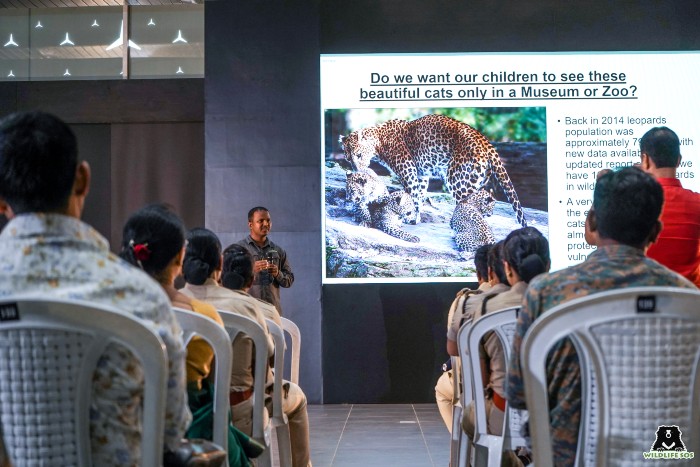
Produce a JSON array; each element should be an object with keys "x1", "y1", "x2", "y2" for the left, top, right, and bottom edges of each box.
[{"x1": 639, "y1": 127, "x2": 700, "y2": 287}]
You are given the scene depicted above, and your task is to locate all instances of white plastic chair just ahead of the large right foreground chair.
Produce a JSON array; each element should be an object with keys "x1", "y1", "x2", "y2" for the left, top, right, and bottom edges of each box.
[{"x1": 461, "y1": 307, "x2": 526, "y2": 467}]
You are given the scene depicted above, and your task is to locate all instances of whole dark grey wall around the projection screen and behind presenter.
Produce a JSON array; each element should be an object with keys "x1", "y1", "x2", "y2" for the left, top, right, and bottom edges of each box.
[{"x1": 211, "y1": 0, "x2": 700, "y2": 402}]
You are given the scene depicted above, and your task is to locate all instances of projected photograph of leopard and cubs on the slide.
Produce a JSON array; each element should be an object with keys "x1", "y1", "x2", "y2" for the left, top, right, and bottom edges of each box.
[{"x1": 322, "y1": 107, "x2": 549, "y2": 282}]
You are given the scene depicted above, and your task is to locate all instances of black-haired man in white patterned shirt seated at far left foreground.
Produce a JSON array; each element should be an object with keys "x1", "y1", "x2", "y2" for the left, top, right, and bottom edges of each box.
[{"x1": 0, "y1": 112, "x2": 191, "y2": 466}]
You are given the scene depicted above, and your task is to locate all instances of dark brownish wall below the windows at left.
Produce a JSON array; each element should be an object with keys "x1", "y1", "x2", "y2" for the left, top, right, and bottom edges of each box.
[{"x1": 0, "y1": 79, "x2": 204, "y2": 250}]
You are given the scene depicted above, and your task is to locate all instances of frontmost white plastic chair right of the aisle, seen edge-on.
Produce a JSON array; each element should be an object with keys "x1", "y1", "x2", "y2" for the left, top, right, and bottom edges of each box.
[{"x1": 450, "y1": 319, "x2": 474, "y2": 467}]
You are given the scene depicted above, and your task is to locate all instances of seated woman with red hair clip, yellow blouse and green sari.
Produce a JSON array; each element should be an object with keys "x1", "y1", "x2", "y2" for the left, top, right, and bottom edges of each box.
[{"x1": 119, "y1": 218, "x2": 264, "y2": 467}]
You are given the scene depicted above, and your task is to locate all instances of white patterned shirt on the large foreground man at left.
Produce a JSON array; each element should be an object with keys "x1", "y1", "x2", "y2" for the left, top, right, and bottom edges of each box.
[{"x1": 0, "y1": 214, "x2": 191, "y2": 466}]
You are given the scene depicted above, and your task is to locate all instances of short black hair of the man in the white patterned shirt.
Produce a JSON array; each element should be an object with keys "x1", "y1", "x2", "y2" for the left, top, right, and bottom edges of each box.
[{"x1": 0, "y1": 112, "x2": 78, "y2": 214}]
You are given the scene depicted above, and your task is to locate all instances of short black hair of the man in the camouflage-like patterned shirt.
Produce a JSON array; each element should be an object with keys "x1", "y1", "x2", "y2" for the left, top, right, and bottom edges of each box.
[{"x1": 593, "y1": 167, "x2": 664, "y2": 246}]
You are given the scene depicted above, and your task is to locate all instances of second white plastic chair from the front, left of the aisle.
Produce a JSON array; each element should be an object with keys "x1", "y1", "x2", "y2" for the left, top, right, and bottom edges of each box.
[{"x1": 265, "y1": 319, "x2": 292, "y2": 467}]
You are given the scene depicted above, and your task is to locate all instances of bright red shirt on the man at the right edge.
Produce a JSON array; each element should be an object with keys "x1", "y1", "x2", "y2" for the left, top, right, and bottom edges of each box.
[{"x1": 647, "y1": 178, "x2": 700, "y2": 287}]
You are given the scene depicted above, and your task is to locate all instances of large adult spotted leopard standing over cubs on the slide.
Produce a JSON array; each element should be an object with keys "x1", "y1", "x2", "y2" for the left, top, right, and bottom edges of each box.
[{"x1": 340, "y1": 114, "x2": 527, "y2": 226}]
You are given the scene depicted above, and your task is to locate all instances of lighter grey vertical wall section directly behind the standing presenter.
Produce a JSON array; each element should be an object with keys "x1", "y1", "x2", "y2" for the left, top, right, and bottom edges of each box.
[{"x1": 205, "y1": 0, "x2": 322, "y2": 403}]
